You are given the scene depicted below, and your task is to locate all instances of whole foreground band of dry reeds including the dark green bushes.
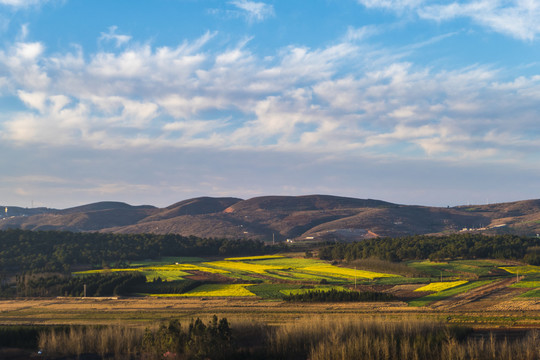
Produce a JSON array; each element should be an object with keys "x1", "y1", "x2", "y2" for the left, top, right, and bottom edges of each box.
[{"x1": 31, "y1": 316, "x2": 540, "y2": 360}]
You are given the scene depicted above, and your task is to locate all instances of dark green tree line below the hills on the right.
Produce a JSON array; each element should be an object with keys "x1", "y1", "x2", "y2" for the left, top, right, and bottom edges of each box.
[{"x1": 319, "y1": 234, "x2": 540, "y2": 265}]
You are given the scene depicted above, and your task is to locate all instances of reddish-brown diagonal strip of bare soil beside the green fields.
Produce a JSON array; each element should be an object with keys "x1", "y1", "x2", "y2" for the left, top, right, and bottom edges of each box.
[{"x1": 429, "y1": 278, "x2": 517, "y2": 310}]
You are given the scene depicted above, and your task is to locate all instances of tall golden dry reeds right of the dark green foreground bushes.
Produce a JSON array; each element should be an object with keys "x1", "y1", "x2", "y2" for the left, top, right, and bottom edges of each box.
[{"x1": 269, "y1": 318, "x2": 540, "y2": 360}]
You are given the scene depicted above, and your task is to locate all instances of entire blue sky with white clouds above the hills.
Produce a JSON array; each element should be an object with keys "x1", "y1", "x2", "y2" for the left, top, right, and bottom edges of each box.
[{"x1": 0, "y1": 0, "x2": 540, "y2": 208}]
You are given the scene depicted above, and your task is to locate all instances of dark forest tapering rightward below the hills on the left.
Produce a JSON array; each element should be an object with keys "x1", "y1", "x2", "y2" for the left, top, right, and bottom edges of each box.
[{"x1": 0, "y1": 229, "x2": 283, "y2": 273}]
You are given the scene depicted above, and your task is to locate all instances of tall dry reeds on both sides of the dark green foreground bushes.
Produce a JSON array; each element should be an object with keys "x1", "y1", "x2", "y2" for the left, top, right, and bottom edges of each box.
[{"x1": 35, "y1": 317, "x2": 540, "y2": 360}]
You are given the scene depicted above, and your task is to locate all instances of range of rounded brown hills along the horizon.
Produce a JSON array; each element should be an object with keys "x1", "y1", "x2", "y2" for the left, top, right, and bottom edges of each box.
[{"x1": 0, "y1": 195, "x2": 540, "y2": 241}]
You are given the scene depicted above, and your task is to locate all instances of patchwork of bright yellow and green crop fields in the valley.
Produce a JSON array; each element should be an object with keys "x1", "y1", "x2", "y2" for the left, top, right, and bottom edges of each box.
[{"x1": 67, "y1": 255, "x2": 540, "y2": 306}]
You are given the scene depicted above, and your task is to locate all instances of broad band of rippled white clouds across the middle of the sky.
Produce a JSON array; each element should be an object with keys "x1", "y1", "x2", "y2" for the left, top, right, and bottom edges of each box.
[{"x1": 0, "y1": 28, "x2": 540, "y2": 165}]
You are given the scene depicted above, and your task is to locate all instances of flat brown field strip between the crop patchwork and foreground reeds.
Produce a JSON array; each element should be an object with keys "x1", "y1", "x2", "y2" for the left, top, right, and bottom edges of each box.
[{"x1": 0, "y1": 298, "x2": 540, "y2": 328}]
